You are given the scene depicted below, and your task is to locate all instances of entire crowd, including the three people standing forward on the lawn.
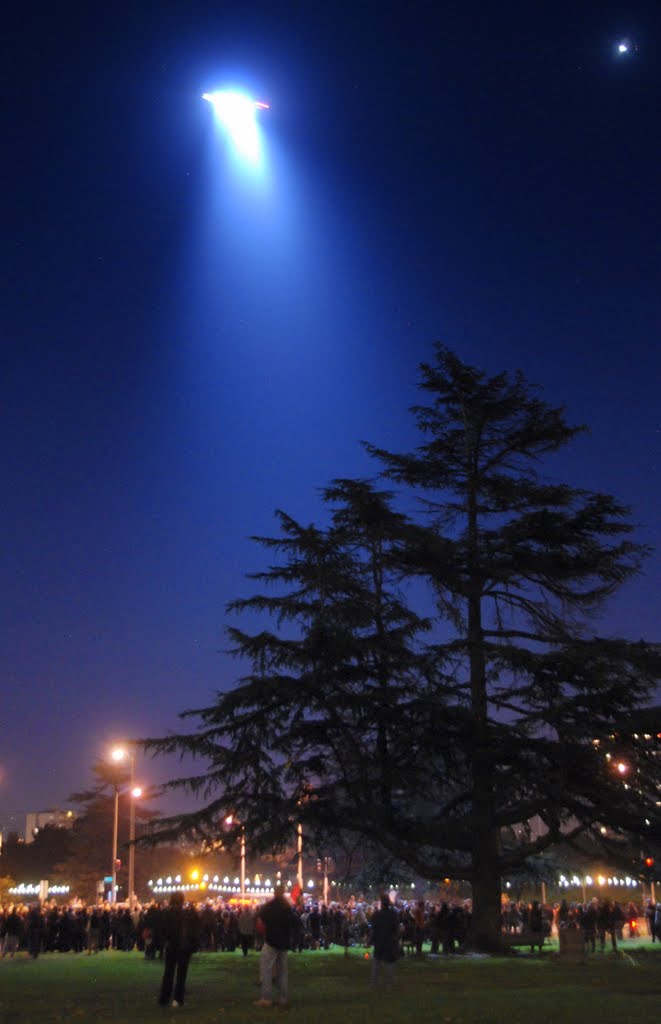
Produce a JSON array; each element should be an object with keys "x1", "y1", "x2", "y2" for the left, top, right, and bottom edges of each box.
[{"x1": 5, "y1": 887, "x2": 661, "y2": 1007}]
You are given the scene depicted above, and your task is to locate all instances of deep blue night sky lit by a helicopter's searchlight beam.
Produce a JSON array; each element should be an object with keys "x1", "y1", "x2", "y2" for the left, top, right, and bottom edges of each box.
[{"x1": 0, "y1": 0, "x2": 661, "y2": 814}]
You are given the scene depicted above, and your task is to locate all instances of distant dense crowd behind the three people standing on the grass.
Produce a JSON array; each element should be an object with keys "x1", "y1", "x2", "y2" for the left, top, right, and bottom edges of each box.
[{"x1": 0, "y1": 898, "x2": 661, "y2": 959}]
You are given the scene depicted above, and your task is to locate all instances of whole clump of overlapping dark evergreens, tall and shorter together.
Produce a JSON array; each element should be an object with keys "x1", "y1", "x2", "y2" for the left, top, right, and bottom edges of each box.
[{"x1": 147, "y1": 346, "x2": 661, "y2": 948}]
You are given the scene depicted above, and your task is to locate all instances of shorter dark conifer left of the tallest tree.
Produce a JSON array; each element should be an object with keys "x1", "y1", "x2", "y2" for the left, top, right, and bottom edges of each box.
[{"x1": 145, "y1": 480, "x2": 442, "y2": 848}]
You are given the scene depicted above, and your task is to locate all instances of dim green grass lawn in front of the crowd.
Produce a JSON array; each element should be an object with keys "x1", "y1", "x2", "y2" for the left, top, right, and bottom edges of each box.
[{"x1": 0, "y1": 945, "x2": 661, "y2": 1024}]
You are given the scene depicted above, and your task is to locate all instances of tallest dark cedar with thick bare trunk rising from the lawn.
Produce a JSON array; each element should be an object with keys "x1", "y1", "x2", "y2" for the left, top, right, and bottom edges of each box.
[{"x1": 367, "y1": 345, "x2": 661, "y2": 948}]
